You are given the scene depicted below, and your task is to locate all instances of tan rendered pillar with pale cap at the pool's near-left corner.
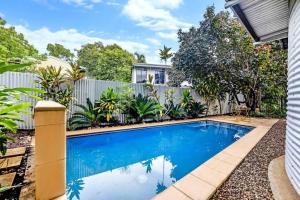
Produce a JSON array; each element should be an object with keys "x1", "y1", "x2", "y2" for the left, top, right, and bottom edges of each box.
[{"x1": 34, "y1": 101, "x2": 66, "y2": 200}]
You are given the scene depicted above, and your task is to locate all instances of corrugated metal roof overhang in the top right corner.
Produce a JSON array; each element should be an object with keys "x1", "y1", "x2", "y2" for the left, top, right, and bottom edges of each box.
[{"x1": 225, "y1": 0, "x2": 289, "y2": 42}]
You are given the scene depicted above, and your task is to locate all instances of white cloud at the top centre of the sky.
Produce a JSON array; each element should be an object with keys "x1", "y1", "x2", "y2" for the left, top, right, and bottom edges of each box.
[{"x1": 123, "y1": 0, "x2": 191, "y2": 31}]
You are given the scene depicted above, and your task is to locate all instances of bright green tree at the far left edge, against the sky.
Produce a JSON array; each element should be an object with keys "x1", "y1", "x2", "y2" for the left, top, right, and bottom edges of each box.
[{"x1": 0, "y1": 17, "x2": 39, "y2": 61}]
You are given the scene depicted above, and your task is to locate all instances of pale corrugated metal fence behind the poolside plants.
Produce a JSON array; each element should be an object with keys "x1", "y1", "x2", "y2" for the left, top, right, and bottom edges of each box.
[{"x1": 0, "y1": 72, "x2": 231, "y2": 129}]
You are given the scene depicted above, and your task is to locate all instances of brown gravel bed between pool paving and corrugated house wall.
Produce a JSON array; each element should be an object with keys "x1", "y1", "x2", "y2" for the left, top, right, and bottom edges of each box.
[{"x1": 211, "y1": 120, "x2": 286, "y2": 200}]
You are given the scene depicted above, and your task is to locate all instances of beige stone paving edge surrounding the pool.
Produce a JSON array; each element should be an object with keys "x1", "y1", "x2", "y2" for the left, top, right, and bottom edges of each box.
[{"x1": 67, "y1": 117, "x2": 278, "y2": 200}]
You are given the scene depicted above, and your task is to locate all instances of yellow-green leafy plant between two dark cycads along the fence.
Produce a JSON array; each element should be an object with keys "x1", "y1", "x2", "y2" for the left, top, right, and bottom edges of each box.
[{"x1": 95, "y1": 87, "x2": 119, "y2": 122}]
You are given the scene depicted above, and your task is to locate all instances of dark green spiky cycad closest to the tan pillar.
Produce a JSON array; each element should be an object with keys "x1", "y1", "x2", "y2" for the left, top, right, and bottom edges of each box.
[{"x1": 69, "y1": 98, "x2": 104, "y2": 130}]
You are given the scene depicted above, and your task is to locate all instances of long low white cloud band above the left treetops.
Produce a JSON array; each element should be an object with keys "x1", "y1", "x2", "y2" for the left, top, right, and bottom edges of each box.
[{"x1": 15, "y1": 25, "x2": 149, "y2": 53}]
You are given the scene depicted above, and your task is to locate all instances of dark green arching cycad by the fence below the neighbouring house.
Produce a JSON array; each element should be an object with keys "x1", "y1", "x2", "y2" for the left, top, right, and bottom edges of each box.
[{"x1": 128, "y1": 94, "x2": 162, "y2": 122}]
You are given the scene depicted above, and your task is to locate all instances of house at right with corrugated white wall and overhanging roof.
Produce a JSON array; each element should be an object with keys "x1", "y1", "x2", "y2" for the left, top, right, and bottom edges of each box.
[{"x1": 225, "y1": 0, "x2": 300, "y2": 195}]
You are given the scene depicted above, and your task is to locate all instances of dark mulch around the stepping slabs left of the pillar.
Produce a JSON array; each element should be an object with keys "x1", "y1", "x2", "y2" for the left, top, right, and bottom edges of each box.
[{"x1": 0, "y1": 130, "x2": 34, "y2": 200}]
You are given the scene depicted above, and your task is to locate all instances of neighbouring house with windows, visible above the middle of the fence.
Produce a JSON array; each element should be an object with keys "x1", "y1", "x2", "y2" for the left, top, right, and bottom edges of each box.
[{"x1": 132, "y1": 63, "x2": 171, "y2": 85}]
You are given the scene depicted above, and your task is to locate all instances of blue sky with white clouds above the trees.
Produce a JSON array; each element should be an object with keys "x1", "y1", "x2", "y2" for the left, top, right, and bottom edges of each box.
[{"x1": 0, "y1": 0, "x2": 225, "y2": 63}]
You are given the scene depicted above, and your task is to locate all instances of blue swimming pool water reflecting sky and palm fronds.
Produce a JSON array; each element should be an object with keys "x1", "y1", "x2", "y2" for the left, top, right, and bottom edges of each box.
[{"x1": 67, "y1": 121, "x2": 252, "y2": 200}]
